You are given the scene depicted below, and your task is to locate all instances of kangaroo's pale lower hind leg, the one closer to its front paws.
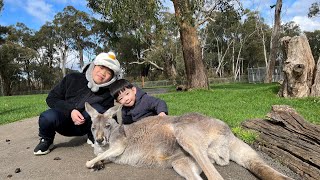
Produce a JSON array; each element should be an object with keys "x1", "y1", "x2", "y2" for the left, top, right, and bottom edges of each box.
[{"x1": 172, "y1": 156, "x2": 202, "y2": 180}]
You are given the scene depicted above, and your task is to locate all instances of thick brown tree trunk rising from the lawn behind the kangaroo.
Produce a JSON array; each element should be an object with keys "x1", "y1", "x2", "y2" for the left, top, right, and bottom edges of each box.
[{"x1": 172, "y1": 0, "x2": 209, "y2": 89}]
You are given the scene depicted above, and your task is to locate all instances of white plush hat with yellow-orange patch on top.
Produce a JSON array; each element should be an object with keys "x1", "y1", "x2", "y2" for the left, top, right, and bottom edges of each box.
[{"x1": 86, "y1": 52, "x2": 122, "y2": 92}]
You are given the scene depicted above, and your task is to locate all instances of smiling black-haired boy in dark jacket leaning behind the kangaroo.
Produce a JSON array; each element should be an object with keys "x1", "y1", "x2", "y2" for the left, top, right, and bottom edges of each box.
[{"x1": 109, "y1": 79, "x2": 168, "y2": 124}]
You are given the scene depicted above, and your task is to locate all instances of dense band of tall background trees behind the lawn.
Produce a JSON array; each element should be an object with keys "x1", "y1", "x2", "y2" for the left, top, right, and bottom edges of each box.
[{"x1": 0, "y1": 0, "x2": 320, "y2": 95}]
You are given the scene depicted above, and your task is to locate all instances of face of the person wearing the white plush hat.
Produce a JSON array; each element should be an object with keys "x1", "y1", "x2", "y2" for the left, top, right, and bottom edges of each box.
[{"x1": 92, "y1": 65, "x2": 113, "y2": 84}]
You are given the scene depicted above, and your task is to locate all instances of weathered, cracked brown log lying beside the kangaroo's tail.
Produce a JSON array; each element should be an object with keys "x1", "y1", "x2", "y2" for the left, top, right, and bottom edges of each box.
[{"x1": 241, "y1": 105, "x2": 320, "y2": 180}]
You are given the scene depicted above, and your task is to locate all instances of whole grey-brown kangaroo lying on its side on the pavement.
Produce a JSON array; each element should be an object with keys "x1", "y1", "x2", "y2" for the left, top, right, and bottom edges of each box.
[{"x1": 85, "y1": 103, "x2": 290, "y2": 180}]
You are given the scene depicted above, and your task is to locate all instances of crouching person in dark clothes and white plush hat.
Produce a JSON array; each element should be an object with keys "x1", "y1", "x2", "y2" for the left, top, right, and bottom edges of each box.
[{"x1": 33, "y1": 52, "x2": 122, "y2": 155}]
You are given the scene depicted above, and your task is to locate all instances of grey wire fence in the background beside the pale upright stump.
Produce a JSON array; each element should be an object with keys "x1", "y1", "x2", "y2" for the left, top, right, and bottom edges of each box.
[{"x1": 248, "y1": 66, "x2": 283, "y2": 83}]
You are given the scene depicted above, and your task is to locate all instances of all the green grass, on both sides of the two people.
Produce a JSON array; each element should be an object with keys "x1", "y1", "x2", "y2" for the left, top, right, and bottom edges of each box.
[{"x1": 0, "y1": 83, "x2": 320, "y2": 142}]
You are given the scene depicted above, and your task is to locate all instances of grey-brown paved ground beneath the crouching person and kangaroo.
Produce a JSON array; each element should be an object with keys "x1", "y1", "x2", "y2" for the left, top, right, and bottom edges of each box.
[{"x1": 0, "y1": 117, "x2": 295, "y2": 180}]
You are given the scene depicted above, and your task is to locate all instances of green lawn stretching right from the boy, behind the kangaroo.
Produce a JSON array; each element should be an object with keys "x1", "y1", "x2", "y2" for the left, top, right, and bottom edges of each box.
[{"x1": 158, "y1": 84, "x2": 320, "y2": 127}]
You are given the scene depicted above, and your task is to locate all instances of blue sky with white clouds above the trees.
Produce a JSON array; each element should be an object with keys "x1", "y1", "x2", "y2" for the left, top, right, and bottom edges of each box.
[{"x1": 0, "y1": 0, "x2": 320, "y2": 31}]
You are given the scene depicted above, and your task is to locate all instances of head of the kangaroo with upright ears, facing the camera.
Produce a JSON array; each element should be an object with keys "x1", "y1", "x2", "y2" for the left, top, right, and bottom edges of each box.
[{"x1": 85, "y1": 102, "x2": 122, "y2": 146}]
